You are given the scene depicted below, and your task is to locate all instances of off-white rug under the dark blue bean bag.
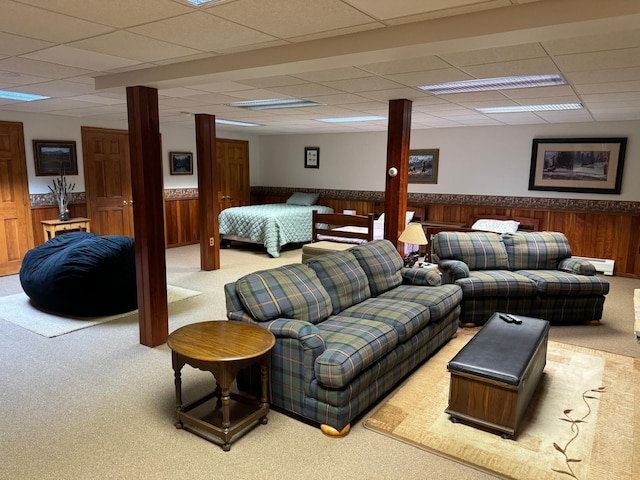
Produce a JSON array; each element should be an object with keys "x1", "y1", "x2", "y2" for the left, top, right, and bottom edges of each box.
[{"x1": 0, "y1": 285, "x2": 202, "y2": 338}]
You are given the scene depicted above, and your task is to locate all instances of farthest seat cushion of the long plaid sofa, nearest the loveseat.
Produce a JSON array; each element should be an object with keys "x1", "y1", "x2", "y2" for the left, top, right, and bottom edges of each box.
[{"x1": 380, "y1": 285, "x2": 462, "y2": 322}]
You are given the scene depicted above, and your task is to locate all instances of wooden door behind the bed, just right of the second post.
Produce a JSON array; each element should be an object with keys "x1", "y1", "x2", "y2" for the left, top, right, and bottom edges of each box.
[{"x1": 216, "y1": 140, "x2": 250, "y2": 211}]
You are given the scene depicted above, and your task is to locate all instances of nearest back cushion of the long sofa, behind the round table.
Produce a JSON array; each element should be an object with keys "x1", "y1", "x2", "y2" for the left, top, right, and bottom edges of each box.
[{"x1": 236, "y1": 265, "x2": 333, "y2": 323}]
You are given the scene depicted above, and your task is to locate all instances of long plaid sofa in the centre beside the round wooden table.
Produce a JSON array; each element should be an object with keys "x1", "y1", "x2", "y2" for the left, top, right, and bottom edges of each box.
[{"x1": 225, "y1": 240, "x2": 462, "y2": 433}]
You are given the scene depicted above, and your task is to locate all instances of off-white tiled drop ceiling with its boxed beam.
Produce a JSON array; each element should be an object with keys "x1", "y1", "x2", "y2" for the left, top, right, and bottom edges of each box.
[{"x1": 0, "y1": 0, "x2": 640, "y2": 134}]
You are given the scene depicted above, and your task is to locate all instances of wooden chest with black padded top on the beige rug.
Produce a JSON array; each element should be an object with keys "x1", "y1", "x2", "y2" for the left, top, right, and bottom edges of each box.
[{"x1": 445, "y1": 313, "x2": 549, "y2": 437}]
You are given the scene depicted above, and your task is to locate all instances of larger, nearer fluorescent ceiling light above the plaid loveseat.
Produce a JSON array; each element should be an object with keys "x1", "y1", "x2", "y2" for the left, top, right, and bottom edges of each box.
[{"x1": 418, "y1": 73, "x2": 567, "y2": 95}]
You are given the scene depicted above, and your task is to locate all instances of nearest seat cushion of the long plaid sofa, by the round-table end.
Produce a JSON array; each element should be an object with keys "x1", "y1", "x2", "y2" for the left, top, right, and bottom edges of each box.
[{"x1": 314, "y1": 316, "x2": 398, "y2": 388}]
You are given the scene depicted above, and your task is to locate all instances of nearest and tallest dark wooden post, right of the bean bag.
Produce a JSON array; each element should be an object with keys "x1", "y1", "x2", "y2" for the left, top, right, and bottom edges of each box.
[{"x1": 127, "y1": 86, "x2": 169, "y2": 347}]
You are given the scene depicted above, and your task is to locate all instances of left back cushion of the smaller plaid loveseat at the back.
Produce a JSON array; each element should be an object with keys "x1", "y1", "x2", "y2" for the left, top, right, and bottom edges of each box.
[{"x1": 433, "y1": 232, "x2": 508, "y2": 270}]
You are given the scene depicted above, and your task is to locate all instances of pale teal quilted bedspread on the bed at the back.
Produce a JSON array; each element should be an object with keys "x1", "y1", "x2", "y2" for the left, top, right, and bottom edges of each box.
[{"x1": 218, "y1": 203, "x2": 333, "y2": 257}]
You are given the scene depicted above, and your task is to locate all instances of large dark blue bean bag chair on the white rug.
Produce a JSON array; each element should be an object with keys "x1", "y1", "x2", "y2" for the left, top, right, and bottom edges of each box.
[{"x1": 20, "y1": 232, "x2": 138, "y2": 317}]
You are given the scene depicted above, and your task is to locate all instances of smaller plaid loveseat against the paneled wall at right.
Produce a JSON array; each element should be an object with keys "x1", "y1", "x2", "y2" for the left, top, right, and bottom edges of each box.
[{"x1": 433, "y1": 232, "x2": 609, "y2": 325}]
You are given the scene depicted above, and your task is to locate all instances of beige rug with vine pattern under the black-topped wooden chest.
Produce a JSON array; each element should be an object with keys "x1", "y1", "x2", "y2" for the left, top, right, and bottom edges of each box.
[{"x1": 365, "y1": 331, "x2": 640, "y2": 480}]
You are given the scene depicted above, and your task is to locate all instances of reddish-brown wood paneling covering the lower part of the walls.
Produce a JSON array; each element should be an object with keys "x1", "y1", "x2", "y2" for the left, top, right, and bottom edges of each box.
[{"x1": 32, "y1": 192, "x2": 640, "y2": 278}]
